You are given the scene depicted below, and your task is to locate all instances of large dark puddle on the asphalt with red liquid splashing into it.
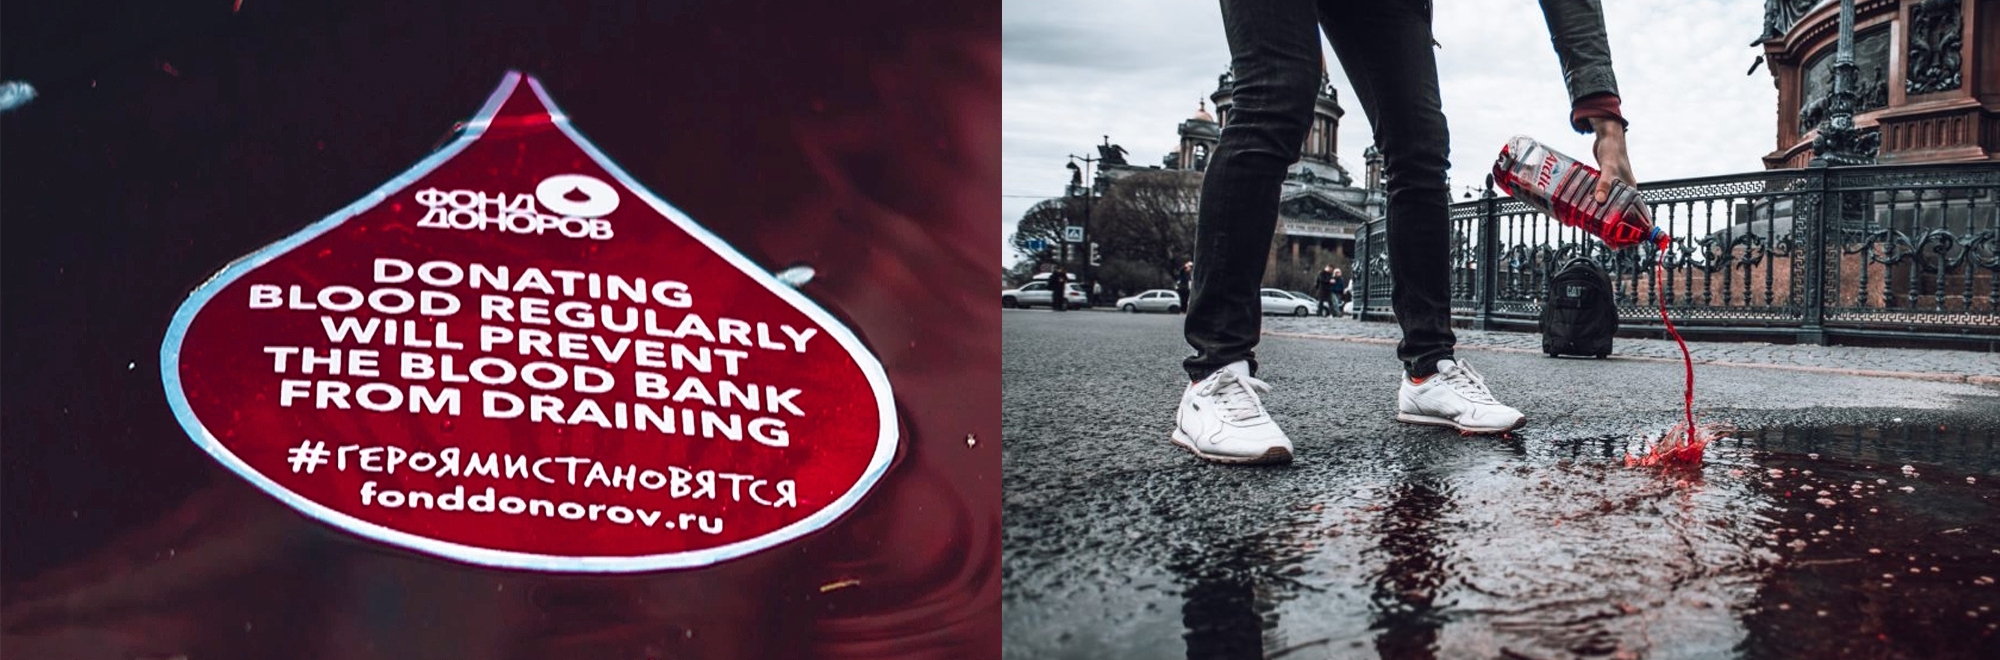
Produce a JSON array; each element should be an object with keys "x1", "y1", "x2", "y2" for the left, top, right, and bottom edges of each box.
[{"x1": 1008, "y1": 426, "x2": 2000, "y2": 658}]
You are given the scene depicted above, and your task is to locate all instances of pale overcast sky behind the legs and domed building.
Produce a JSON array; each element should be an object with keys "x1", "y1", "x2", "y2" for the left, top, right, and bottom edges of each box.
[{"x1": 1000, "y1": 0, "x2": 1778, "y2": 264}]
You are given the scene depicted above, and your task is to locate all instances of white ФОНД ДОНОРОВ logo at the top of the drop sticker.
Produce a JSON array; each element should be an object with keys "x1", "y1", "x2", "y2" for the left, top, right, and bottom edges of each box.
[{"x1": 414, "y1": 174, "x2": 618, "y2": 240}]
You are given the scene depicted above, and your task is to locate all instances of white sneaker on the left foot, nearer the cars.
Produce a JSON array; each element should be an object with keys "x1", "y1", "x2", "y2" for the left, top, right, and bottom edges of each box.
[{"x1": 1174, "y1": 362, "x2": 1292, "y2": 464}]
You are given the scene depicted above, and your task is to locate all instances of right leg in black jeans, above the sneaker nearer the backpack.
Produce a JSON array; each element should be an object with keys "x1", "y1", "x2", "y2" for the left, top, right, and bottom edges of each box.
[{"x1": 1320, "y1": 0, "x2": 1456, "y2": 378}]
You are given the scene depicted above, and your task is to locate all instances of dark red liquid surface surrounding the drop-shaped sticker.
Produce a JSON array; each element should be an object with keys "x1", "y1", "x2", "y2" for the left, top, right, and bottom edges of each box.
[{"x1": 0, "y1": 0, "x2": 1000, "y2": 658}]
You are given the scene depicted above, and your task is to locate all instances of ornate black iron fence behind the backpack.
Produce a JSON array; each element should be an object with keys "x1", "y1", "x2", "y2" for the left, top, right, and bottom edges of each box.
[{"x1": 1354, "y1": 162, "x2": 2000, "y2": 348}]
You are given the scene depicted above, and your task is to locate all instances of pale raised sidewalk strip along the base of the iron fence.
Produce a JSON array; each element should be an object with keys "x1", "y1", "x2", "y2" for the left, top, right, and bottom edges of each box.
[{"x1": 1264, "y1": 316, "x2": 2000, "y2": 384}]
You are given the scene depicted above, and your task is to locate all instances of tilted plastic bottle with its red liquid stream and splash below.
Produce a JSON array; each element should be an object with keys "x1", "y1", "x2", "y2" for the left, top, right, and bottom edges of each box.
[{"x1": 1494, "y1": 136, "x2": 1716, "y2": 466}]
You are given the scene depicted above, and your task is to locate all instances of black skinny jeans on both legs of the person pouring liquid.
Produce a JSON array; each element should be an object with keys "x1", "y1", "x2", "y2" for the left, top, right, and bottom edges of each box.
[{"x1": 1182, "y1": 0, "x2": 1456, "y2": 380}]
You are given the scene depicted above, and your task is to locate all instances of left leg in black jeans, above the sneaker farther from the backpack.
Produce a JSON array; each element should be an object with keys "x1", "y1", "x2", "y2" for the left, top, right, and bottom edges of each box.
[{"x1": 1182, "y1": 0, "x2": 1320, "y2": 380}]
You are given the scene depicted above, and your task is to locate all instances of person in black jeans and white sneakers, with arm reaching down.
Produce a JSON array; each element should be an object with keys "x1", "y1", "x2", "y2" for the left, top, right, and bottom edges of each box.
[{"x1": 1172, "y1": 0, "x2": 1634, "y2": 464}]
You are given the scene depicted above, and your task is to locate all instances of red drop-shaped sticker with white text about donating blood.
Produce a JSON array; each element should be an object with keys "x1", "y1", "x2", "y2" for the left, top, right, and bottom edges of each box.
[{"x1": 160, "y1": 72, "x2": 898, "y2": 572}]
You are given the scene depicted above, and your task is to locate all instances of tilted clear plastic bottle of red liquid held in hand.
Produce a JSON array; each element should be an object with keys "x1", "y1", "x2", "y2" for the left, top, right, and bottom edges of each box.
[{"x1": 1494, "y1": 136, "x2": 1674, "y2": 250}]
